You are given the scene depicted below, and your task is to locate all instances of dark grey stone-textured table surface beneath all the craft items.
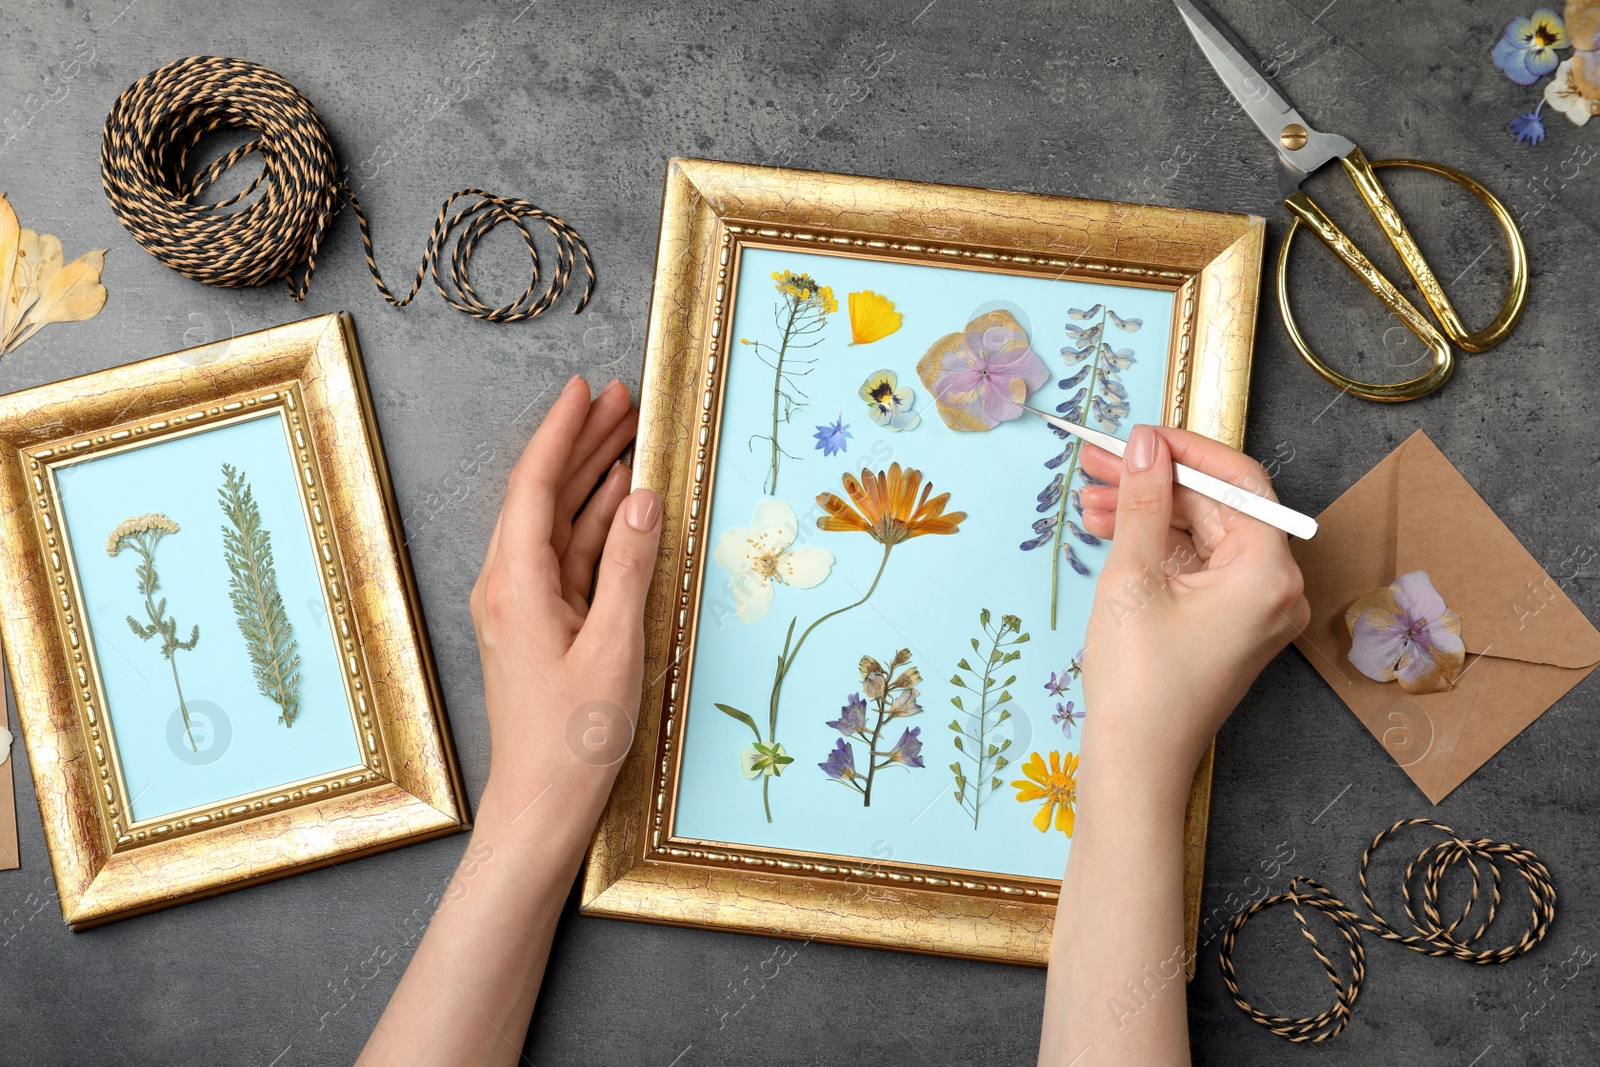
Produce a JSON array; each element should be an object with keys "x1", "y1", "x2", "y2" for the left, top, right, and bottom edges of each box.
[{"x1": 0, "y1": 0, "x2": 1600, "y2": 1067}]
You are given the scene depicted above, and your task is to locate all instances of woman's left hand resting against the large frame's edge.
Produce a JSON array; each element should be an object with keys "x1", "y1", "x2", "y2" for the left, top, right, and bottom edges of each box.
[{"x1": 472, "y1": 378, "x2": 661, "y2": 845}]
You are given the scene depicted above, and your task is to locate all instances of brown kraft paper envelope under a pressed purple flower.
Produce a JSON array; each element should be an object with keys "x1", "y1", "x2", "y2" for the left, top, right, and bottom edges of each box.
[{"x1": 1291, "y1": 430, "x2": 1600, "y2": 805}]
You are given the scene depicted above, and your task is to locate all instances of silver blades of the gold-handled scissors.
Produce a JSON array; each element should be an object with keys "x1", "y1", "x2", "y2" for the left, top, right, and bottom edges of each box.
[{"x1": 1173, "y1": 0, "x2": 1355, "y2": 187}]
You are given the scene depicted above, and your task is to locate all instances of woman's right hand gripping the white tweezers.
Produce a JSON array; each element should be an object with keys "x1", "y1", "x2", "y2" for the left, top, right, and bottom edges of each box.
[{"x1": 1080, "y1": 426, "x2": 1310, "y2": 801}]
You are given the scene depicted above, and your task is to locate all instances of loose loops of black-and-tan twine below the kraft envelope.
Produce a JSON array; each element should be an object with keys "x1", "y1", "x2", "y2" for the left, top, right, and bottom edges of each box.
[{"x1": 1218, "y1": 819, "x2": 1555, "y2": 1043}]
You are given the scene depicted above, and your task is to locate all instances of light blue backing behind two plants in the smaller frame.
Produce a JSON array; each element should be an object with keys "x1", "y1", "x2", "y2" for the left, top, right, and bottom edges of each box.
[{"x1": 56, "y1": 413, "x2": 360, "y2": 821}]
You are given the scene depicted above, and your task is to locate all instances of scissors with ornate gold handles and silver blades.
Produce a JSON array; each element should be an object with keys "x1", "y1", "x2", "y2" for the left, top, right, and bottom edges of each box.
[{"x1": 1174, "y1": 0, "x2": 1528, "y2": 402}]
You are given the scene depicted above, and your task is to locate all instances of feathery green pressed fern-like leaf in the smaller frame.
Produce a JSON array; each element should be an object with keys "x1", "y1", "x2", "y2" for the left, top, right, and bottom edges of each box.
[{"x1": 218, "y1": 464, "x2": 301, "y2": 726}]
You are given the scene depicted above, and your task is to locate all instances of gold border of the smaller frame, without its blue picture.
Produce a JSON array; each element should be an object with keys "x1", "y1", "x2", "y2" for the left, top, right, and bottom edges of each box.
[{"x1": 0, "y1": 314, "x2": 469, "y2": 929}]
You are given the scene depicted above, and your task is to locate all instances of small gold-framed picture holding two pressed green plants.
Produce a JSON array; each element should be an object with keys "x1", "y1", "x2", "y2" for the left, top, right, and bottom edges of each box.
[{"x1": 0, "y1": 314, "x2": 469, "y2": 929}]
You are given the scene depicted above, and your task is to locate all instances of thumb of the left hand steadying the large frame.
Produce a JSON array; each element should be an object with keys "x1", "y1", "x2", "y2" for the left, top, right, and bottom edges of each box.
[{"x1": 578, "y1": 488, "x2": 661, "y2": 672}]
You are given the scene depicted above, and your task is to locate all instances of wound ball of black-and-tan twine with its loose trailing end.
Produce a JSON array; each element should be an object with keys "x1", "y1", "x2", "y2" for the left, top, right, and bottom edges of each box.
[{"x1": 101, "y1": 56, "x2": 595, "y2": 322}]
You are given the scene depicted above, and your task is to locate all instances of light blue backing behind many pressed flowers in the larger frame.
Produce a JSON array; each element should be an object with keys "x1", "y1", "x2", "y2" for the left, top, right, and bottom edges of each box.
[{"x1": 674, "y1": 250, "x2": 1173, "y2": 878}]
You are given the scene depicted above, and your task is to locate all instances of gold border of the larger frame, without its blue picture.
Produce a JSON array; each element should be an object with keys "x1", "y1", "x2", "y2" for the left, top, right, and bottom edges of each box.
[{"x1": 582, "y1": 160, "x2": 1266, "y2": 965}]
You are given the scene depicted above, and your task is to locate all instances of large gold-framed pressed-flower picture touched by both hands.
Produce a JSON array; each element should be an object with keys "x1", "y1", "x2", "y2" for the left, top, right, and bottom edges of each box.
[{"x1": 582, "y1": 160, "x2": 1266, "y2": 965}]
